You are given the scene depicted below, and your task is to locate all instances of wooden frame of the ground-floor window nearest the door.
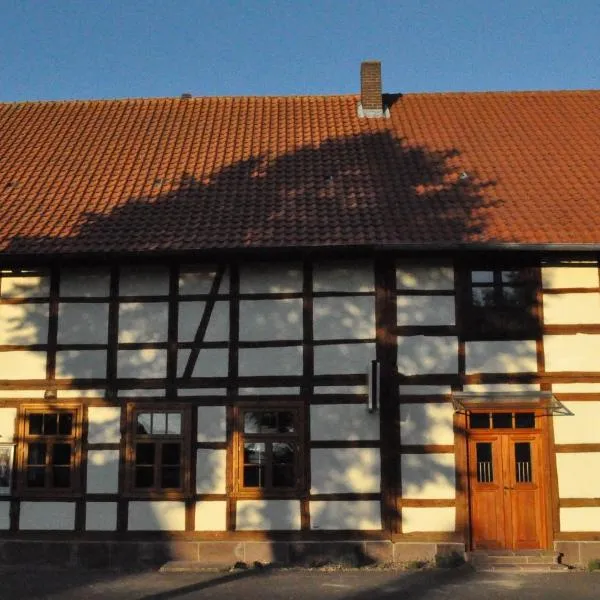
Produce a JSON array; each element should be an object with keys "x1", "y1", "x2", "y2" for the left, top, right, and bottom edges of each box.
[{"x1": 233, "y1": 400, "x2": 308, "y2": 499}]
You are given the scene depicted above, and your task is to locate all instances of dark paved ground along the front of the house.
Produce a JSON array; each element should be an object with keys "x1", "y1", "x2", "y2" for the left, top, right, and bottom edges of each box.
[{"x1": 0, "y1": 567, "x2": 600, "y2": 600}]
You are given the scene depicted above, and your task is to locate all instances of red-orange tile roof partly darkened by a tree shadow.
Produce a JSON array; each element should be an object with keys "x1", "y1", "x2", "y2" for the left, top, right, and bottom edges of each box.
[{"x1": 0, "y1": 91, "x2": 600, "y2": 255}]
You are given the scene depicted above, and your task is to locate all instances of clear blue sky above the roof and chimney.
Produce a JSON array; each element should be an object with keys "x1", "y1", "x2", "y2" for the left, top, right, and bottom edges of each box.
[{"x1": 0, "y1": 0, "x2": 600, "y2": 101}]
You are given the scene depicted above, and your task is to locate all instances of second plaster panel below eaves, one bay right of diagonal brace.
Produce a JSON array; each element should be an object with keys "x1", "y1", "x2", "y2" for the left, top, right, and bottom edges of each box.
[{"x1": 240, "y1": 298, "x2": 302, "y2": 342}]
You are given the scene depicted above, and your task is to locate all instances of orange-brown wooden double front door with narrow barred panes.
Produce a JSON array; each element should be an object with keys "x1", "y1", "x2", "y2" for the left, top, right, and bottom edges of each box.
[{"x1": 468, "y1": 413, "x2": 545, "y2": 550}]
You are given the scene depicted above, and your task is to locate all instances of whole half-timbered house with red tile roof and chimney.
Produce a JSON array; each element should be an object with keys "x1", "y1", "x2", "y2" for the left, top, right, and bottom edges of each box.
[{"x1": 0, "y1": 62, "x2": 600, "y2": 564}]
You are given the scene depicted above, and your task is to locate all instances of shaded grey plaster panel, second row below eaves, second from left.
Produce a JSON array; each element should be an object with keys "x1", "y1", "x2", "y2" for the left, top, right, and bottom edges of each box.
[{"x1": 58, "y1": 302, "x2": 108, "y2": 344}]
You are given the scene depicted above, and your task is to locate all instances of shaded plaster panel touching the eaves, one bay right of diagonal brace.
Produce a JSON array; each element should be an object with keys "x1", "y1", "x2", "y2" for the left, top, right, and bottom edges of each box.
[{"x1": 240, "y1": 262, "x2": 303, "y2": 294}]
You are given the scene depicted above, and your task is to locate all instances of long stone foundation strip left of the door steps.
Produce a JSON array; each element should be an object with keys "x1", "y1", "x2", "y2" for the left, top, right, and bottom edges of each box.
[{"x1": 0, "y1": 540, "x2": 466, "y2": 569}]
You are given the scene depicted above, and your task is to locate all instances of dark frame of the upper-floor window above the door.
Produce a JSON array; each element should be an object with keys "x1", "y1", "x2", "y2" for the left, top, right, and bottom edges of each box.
[{"x1": 460, "y1": 265, "x2": 541, "y2": 340}]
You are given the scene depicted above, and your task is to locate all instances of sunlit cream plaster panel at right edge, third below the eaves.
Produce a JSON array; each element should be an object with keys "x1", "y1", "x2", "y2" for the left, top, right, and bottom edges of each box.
[{"x1": 544, "y1": 333, "x2": 600, "y2": 371}]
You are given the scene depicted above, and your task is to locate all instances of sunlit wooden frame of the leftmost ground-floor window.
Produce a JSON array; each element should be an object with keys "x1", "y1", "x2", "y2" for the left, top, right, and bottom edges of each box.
[{"x1": 16, "y1": 404, "x2": 83, "y2": 498}]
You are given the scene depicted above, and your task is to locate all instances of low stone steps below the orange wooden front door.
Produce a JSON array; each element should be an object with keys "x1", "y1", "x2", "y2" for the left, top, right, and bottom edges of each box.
[{"x1": 467, "y1": 550, "x2": 568, "y2": 572}]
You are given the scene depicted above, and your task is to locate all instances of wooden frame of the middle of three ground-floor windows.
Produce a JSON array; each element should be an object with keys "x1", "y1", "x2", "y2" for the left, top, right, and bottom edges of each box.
[{"x1": 125, "y1": 402, "x2": 192, "y2": 500}]
